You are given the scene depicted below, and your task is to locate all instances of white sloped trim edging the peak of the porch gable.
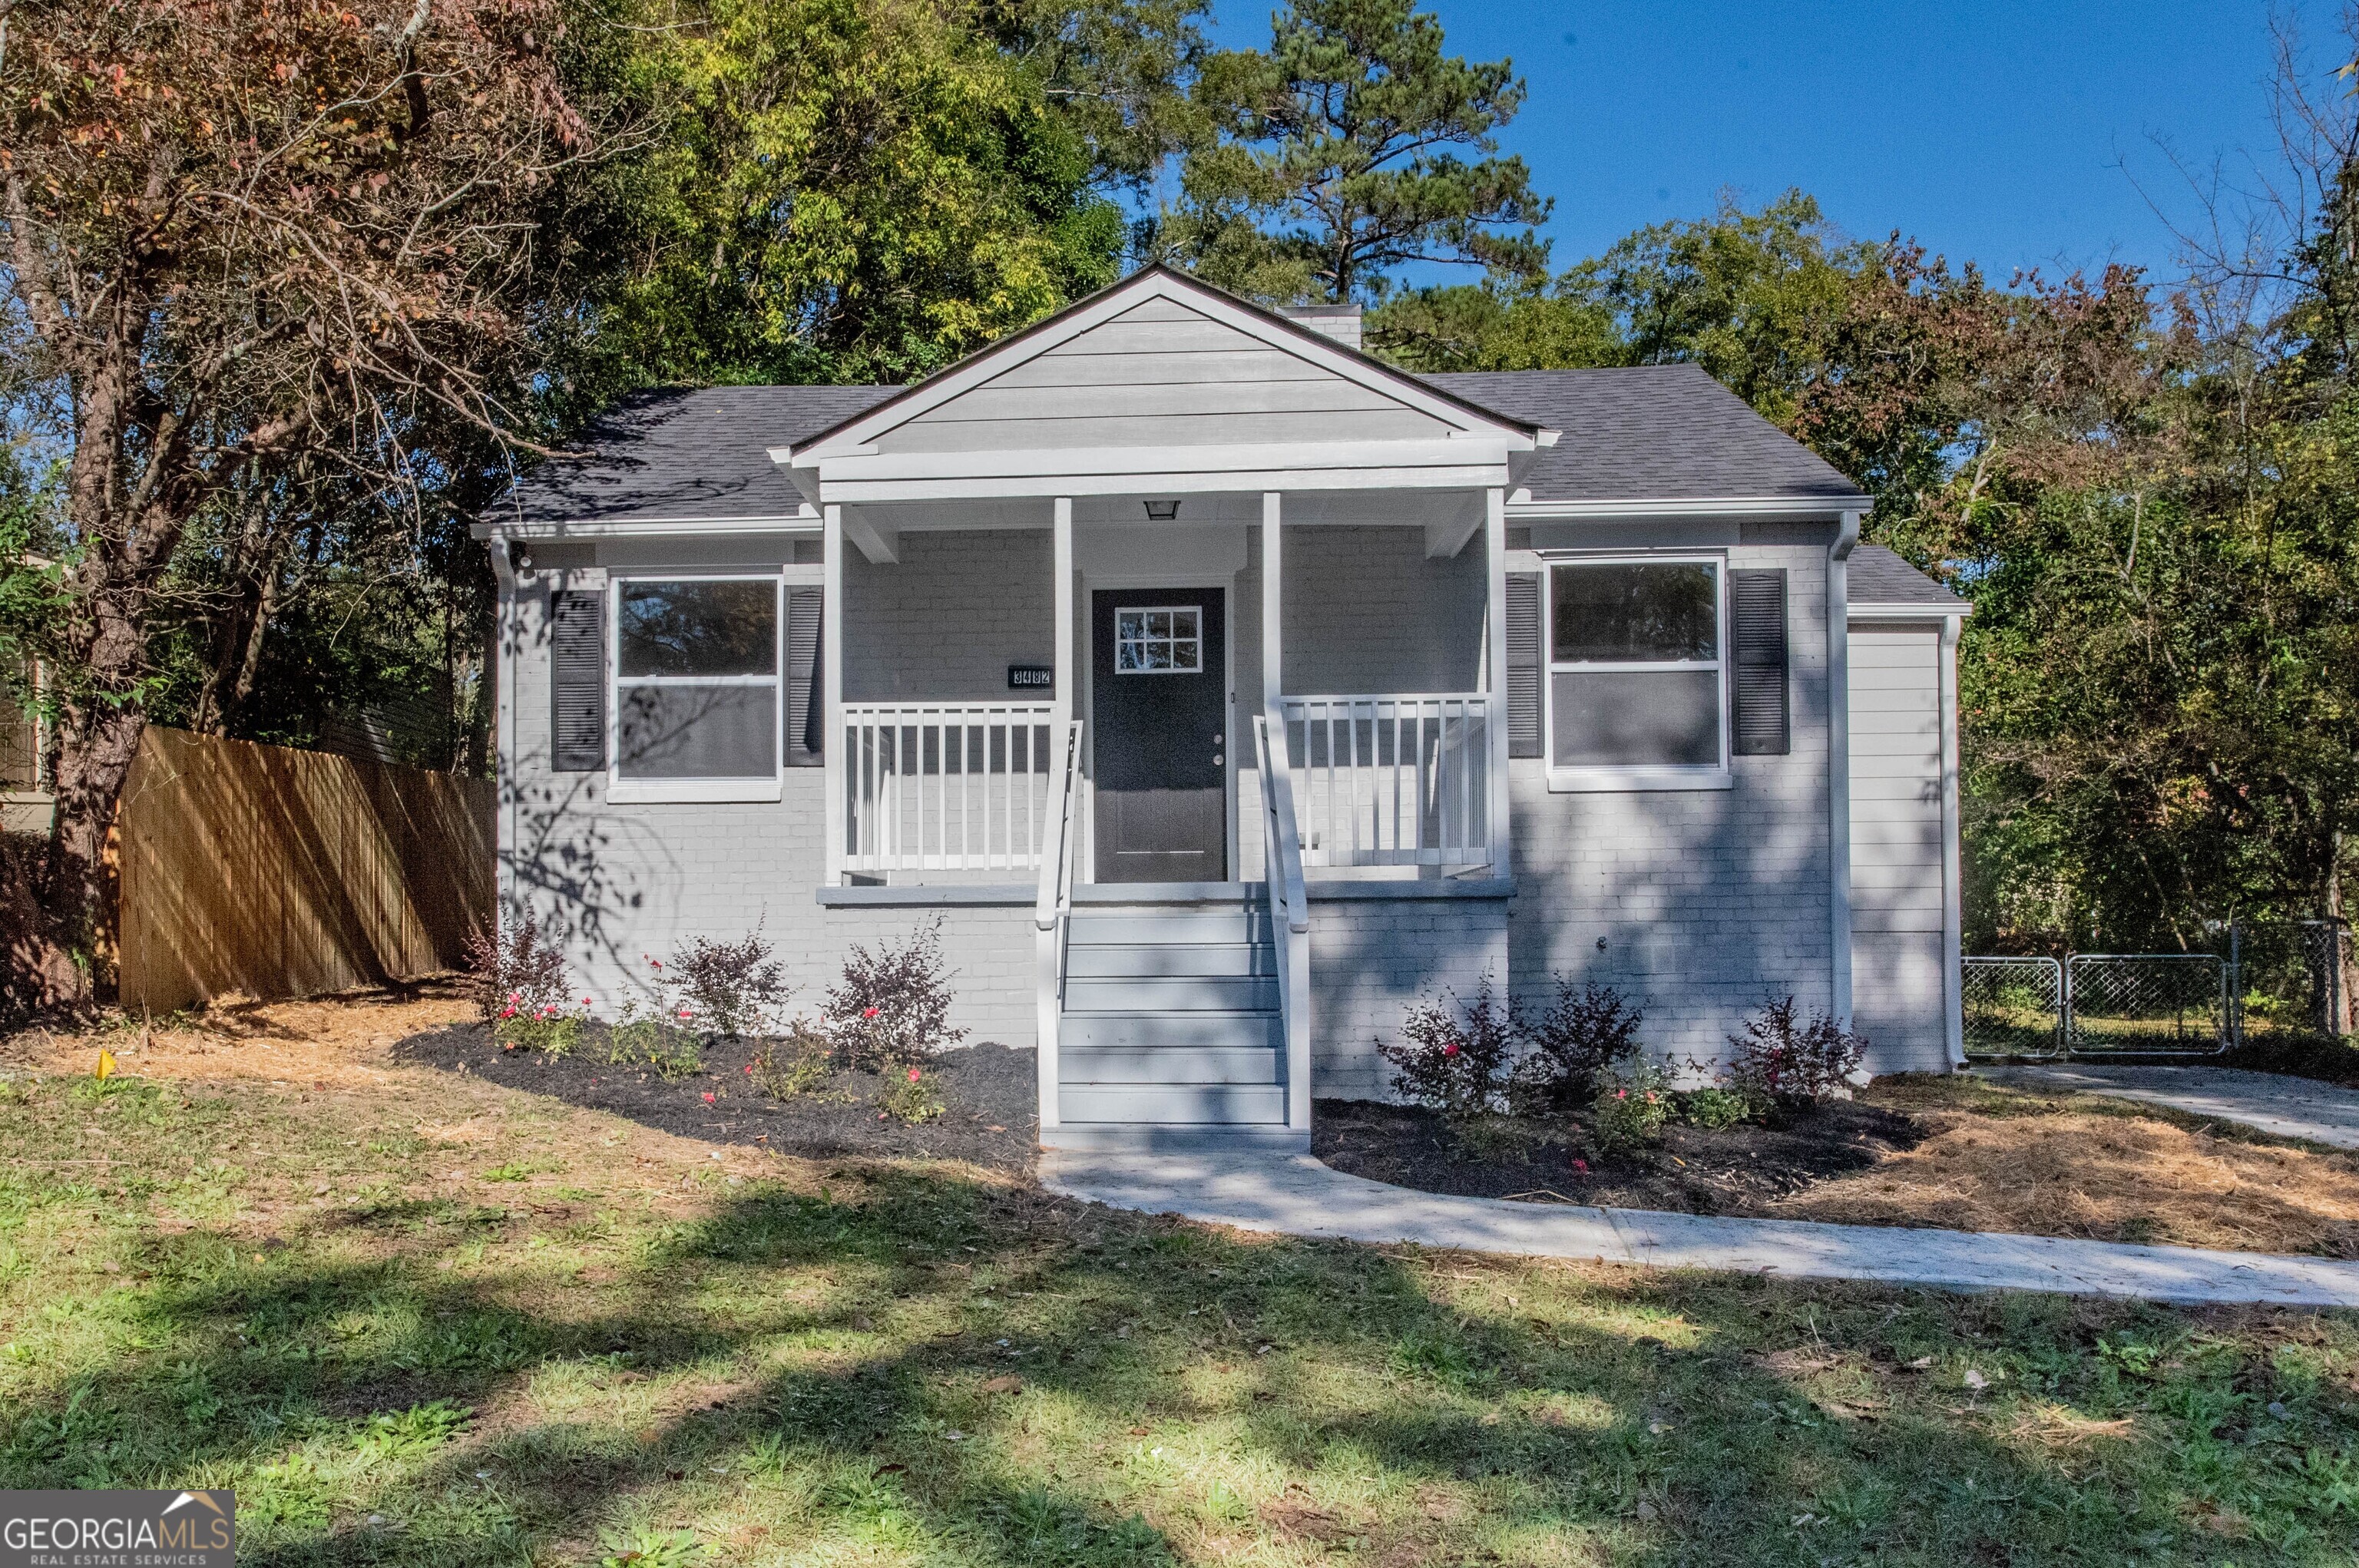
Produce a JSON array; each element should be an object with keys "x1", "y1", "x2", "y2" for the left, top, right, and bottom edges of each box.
[{"x1": 772, "y1": 266, "x2": 1554, "y2": 469}]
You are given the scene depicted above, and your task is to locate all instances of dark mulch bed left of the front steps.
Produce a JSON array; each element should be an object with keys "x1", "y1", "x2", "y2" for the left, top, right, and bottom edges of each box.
[{"x1": 394, "y1": 1024, "x2": 1038, "y2": 1172}]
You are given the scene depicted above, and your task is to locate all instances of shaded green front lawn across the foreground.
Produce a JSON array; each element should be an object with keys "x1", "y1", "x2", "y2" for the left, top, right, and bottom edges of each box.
[{"x1": 0, "y1": 1009, "x2": 2359, "y2": 1568}]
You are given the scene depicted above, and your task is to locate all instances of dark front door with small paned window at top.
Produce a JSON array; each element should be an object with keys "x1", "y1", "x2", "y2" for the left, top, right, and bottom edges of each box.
[{"x1": 1090, "y1": 587, "x2": 1229, "y2": 882}]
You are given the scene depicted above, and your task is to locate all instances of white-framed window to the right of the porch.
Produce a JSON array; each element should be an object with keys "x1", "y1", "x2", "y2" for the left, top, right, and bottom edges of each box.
[{"x1": 1545, "y1": 557, "x2": 1729, "y2": 790}]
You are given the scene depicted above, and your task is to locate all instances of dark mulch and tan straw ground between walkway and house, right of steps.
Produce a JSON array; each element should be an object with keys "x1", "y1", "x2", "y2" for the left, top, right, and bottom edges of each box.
[{"x1": 1312, "y1": 1075, "x2": 2359, "y2": 1259}]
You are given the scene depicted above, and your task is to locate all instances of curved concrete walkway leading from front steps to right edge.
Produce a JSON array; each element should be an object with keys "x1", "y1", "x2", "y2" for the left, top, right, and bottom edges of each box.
[{"x1": 1041, "y1": 1150, "x2": 2359, "y2": 1306}]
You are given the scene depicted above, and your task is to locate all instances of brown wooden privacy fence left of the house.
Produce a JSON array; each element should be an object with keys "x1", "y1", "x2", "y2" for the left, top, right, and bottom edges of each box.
[{"x1": 116, "y1": 724, "x2": 495, "y2": 1011}]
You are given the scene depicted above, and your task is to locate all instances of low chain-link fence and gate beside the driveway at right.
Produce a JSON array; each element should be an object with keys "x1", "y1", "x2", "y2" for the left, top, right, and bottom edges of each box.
[{"x1": 1963, "y1": 920, "x2": 2352, "y2": 1057}]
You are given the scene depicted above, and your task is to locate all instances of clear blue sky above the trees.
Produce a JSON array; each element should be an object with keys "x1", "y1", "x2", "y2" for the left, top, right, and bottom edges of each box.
[{"x1": 1217, "y1": 0, "x2": 2335, "y2": 278}]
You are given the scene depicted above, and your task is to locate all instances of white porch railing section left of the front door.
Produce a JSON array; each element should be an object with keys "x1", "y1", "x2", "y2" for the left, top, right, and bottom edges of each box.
[{"x1": 842, "y1": 703, "x2": 1057, "y2": 875}]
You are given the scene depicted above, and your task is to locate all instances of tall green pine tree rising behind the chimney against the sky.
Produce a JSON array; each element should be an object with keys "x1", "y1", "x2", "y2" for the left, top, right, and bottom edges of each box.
[{"x1": 1149, "y1": 0, "x2": 1550, "y2": 302}]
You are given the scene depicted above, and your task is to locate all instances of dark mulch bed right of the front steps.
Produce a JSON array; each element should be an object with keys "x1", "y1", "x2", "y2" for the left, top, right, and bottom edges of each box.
[{"x1": 1312, "y1": 1099, "x2": 1925, "y2": 1214}]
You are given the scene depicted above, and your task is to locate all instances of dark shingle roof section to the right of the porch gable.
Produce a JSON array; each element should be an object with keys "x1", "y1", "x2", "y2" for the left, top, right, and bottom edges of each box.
[{"x1": 1424, "y1": 366, "x2": 1866, "y2": 502}]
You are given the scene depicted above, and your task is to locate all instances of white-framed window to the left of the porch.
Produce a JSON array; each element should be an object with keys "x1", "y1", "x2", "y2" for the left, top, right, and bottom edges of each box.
[{"x1": 609, "y1": 575, "x2": 786, "y2": 802}]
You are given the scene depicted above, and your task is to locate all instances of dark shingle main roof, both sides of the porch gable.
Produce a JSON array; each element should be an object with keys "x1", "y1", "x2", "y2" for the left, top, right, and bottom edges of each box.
[{"x1": 510, "y1": 366, "x2": 1859, "y2": 524}]
